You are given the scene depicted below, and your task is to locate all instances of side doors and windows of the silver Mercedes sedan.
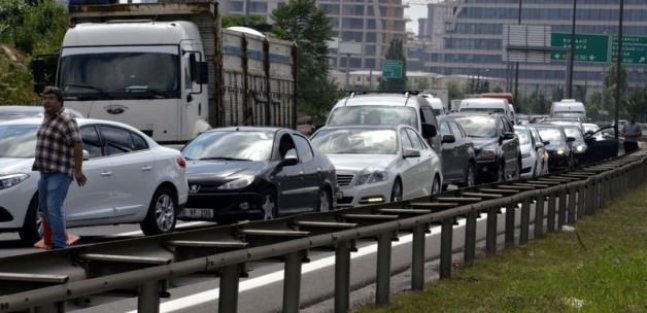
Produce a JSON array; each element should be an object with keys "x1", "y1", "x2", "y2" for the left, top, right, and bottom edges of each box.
[{"x1": 405, "y1": 128, "x2": 434, "y2": 198}]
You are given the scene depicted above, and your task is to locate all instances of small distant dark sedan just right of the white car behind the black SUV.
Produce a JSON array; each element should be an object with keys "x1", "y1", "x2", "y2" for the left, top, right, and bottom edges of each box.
[{"x1": 533, "y1": 124, "x2": 575, "y2": 172}]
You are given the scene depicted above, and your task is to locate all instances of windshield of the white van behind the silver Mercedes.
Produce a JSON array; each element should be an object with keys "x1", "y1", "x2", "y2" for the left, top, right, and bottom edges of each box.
[{"x1": 327, "y1": 105, "x2": 418, "y2": 129}]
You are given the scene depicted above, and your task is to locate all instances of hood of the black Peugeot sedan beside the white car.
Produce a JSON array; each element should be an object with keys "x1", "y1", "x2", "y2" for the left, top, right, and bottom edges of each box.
[{"x1": 186, "y1": 161, "x2": 267, "y2": 179}]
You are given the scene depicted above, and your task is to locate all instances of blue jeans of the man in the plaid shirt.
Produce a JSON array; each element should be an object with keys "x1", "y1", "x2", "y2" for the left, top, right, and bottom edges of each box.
[{"x1": 38, "y1": 173, "x2": 72, "y2": 248}]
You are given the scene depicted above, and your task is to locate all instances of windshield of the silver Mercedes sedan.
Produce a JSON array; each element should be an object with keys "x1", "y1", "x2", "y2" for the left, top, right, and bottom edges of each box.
[{"x1": 310, "y1": 129, "x2": 397, "y2": 154}]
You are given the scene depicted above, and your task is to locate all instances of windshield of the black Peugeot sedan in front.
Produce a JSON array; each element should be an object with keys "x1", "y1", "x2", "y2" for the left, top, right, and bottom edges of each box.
[{"x1": 182, "y1": 131, "x2": 274, "y2": 161}]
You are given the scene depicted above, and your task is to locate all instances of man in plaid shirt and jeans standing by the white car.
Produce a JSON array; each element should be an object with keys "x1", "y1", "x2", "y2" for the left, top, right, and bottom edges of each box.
[{"x1": 33, "y1": 87, "x2": 86, "y2": 249}]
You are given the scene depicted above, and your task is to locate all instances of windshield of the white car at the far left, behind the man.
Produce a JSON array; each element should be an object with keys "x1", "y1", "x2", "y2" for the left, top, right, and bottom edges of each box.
[{"x1": 0, "y1": 124, "x2": 39, "y2": 158}]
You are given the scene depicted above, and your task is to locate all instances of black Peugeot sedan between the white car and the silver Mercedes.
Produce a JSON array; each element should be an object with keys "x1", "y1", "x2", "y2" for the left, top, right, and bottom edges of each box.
[{"x1": 178, "y1": 127, "x2": 338, "y2": 222}]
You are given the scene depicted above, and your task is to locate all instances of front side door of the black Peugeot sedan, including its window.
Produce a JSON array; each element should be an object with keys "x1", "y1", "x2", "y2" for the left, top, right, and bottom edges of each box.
[{"x1": 274, "y1": 132, "x2": 305, "y2": 214}]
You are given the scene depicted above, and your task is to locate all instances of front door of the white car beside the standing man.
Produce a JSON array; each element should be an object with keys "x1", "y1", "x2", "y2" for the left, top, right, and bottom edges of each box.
[{"x1": 65, "y1": 125, "x2": 116, "y2": 222}]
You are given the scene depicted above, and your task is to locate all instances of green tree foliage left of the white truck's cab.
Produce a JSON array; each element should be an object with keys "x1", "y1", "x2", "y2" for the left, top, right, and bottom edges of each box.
[{"x1": 0, "y1": 0, "x2": 68, "y2": 104}]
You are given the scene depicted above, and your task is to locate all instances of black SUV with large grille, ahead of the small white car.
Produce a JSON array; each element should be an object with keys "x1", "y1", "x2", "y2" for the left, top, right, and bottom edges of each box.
[{"x1": 451, "y1": 112, "x2": 521, "y2": 182}]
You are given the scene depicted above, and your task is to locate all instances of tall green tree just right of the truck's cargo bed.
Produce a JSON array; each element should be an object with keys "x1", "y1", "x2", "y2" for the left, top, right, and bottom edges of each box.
[{"x1": 272, "y1": 0, "x2": 339, "y2": 118}]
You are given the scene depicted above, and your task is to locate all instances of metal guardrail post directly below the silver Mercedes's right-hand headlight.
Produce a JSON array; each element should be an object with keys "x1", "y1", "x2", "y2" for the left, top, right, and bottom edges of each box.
[{"x1": 375, "y1": 233, "x2": 393, "y2": 305}]
